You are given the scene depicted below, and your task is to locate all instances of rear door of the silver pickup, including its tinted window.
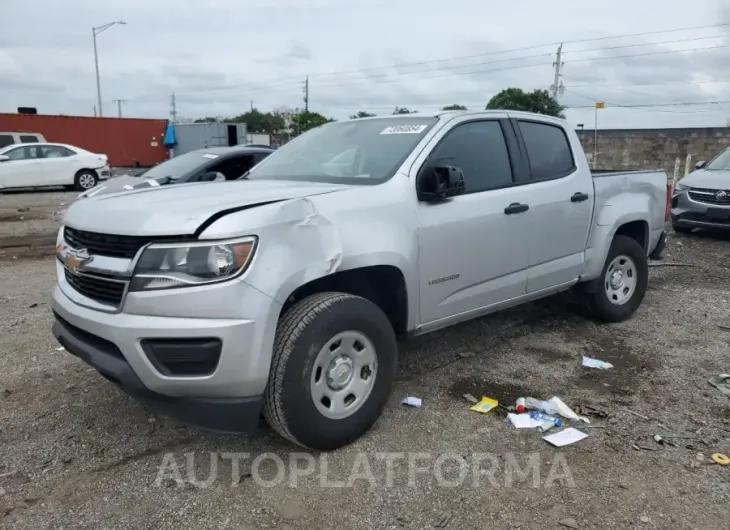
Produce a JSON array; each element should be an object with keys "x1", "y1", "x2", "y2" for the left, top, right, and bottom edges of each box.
[{"x1": 513, "y1": 119, "x2": 593, "y2": 293}]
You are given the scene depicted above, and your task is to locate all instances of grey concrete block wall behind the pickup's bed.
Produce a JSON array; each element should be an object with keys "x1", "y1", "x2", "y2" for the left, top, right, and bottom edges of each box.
[{"x1": 577, "y1": 127, "x2": 730, "y2": 177}]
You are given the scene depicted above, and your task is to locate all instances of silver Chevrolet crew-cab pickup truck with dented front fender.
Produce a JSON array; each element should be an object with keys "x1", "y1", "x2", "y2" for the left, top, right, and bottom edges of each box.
[{"x1": 52, "y1": 111, "x2": 671, "y2": 450}]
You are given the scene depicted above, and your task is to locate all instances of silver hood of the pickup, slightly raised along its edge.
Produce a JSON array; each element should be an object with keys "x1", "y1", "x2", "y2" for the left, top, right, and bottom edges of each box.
[{"x1": 64, "y1": 177, "x2": 349, "y2": 236}]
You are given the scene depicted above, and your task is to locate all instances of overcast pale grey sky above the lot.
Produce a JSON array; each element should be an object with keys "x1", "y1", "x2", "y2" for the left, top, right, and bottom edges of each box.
[{"x1": 0, "y1": 0, "x2": 730, "y2": 128}]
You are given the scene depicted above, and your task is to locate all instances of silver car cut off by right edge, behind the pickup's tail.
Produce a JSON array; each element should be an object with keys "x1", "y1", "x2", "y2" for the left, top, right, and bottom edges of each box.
[{"x1": 672, "y1": 148, "x2": 730, "y2": 234}]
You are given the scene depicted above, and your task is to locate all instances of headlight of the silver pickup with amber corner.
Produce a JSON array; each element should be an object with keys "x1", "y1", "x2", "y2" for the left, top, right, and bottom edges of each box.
[{"x1": 129, "y1": 236, "x2": 257, "y2": 291}]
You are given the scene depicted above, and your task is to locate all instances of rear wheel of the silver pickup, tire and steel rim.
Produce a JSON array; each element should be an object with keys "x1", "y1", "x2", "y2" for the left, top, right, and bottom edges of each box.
[{"x1": 581, "y1": 235, "x2": 649, "y2": 322}]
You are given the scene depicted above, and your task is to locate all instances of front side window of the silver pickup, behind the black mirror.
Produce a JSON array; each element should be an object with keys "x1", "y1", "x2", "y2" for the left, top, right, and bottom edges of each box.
[{"x1": 429, "y1": 120, "x2": 513, "y2": 193}]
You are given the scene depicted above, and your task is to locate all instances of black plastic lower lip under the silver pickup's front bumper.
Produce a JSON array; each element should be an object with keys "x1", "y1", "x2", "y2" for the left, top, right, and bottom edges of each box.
[{"x1": 53, "y1": 315, "x2": 262, "y2": 433}]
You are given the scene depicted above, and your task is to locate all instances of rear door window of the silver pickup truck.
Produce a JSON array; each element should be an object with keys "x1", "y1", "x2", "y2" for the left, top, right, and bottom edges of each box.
[{"x1": 519, "y1": 121, "x2": 575, "y2": 180}]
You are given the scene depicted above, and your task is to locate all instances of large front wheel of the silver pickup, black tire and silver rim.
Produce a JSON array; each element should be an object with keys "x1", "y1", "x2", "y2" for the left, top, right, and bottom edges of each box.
[{"x1": 264, "y1": 292, "x2": 398, "y2": 451}]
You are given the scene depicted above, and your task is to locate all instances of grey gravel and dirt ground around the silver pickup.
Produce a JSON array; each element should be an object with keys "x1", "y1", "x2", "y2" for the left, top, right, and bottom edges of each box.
[{"x1": 0, "y1": 188, "x2": 730, "y2": 529}]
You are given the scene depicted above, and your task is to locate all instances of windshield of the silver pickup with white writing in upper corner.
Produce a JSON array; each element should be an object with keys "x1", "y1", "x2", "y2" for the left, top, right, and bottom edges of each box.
[{"x1": 247, "y1": 117, "x2": 437, "y2": 184}]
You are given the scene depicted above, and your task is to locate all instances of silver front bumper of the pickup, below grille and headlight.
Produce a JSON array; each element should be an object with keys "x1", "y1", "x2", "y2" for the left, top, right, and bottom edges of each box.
[{"x1": 51, "y1": 263, "x2": 281, "y2": 426}]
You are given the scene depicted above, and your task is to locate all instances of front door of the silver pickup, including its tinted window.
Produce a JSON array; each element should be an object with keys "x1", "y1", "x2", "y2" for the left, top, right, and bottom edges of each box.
[{"x1": 413, "y1": 118, "x2": 530, "y2": 324}]
